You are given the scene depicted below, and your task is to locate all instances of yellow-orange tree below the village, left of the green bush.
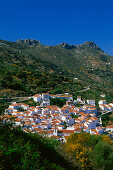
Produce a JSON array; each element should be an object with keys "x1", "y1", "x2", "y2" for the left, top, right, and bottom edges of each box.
[{"x1": 64, "y1": 133, "x2": 92, "y2": 169}]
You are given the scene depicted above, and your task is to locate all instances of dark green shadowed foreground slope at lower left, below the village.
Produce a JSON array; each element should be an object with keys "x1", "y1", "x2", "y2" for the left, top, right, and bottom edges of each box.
[{"x1": 0, "y1": 124, "x2": 78, "y2": 170}]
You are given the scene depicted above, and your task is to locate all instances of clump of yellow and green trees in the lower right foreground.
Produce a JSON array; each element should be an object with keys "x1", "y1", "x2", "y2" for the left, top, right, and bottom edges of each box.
[{"x1": 63, "y1": 133, "x2": 113, "y2": 170}]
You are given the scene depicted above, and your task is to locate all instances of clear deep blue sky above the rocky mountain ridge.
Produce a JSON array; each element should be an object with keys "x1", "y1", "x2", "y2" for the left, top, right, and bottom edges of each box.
[{"x1": 0, "y1": 0, "x2": 113, "y2": 56}]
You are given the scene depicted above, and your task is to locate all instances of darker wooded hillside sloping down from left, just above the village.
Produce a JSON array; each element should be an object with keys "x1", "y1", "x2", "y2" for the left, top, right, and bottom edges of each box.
[{"x1": 0, "y1": 39, "x2": 82, "y2": 96}]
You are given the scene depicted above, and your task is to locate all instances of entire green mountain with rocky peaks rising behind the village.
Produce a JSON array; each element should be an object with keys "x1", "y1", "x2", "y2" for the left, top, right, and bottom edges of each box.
[{"x1": 0, "y1": 39, "x2": 113, "y2": 100}]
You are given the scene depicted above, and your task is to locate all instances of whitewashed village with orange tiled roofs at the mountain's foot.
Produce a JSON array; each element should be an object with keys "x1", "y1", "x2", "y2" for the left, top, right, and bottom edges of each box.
[{"x1": 1, "y1": 93, "x2": 113, "y2": 142}]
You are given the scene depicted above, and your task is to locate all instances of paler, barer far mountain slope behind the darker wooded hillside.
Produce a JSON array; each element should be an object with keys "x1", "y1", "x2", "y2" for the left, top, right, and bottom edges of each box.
[{"x1": 17, "y1": 41, "x2": 113, "y2": 88}]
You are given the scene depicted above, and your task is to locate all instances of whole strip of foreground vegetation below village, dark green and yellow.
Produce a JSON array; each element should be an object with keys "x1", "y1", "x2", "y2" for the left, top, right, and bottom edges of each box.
[{"x1": 0, "y1": 124, "x2": 113, "y2": 170}]
